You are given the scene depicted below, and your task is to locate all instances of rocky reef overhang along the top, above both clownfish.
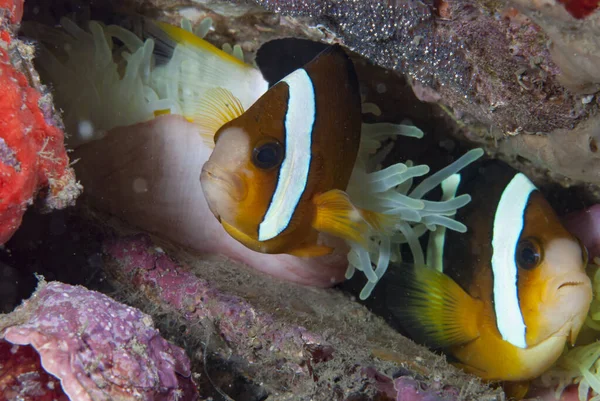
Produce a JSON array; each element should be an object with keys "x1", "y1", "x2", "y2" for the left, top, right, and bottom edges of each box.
[{"x1": 106, "y1": 0, "x2": 600, "y2": 195}]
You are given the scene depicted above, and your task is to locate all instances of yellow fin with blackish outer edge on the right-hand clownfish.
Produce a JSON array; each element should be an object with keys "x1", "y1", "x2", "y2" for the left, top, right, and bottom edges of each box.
[{"x1": 388, "y1": 264, "x2": 481, "y2": 348}]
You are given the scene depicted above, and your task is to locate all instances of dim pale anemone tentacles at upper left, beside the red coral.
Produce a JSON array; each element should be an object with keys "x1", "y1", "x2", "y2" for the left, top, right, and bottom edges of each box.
[{"x1": 25, "y1": 18, "x2": 171, "y2": 147}]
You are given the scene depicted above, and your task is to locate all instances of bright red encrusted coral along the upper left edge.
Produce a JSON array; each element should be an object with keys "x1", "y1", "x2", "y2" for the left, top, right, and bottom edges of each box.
[{"x1": 0, "y1": 2, "x2": 81, "y2": 244}]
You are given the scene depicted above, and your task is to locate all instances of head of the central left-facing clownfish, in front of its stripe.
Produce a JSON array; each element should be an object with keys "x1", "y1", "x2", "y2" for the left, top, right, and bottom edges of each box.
[{"x1": 200, "y1": 85, "x2": 285, "y2": 252}]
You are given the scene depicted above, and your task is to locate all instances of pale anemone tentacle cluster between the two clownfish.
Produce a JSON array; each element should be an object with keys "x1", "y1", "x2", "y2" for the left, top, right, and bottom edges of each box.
[{"x1": 346, "y1": 115, "x2": 483, "y2": 300}]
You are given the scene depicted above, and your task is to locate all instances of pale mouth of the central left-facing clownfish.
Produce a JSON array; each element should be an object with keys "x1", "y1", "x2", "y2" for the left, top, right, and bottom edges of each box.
[{"x1": 200, "y1": 162, "x2": 246, "y2": 202}]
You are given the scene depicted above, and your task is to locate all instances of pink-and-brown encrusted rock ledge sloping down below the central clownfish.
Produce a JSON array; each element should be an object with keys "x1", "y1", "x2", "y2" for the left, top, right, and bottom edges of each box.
[{"x1": 105, "y1": 234, "x2": 498, "y2": 401}]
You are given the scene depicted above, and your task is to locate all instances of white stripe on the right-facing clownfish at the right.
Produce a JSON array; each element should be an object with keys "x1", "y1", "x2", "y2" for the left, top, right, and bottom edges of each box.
[{"x1": 492, "y1": 173, "x2": 536, "y2": 348}]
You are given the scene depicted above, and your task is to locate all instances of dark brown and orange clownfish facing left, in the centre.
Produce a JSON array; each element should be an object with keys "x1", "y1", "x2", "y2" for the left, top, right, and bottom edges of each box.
[{"x1": 200, "y1": 45, "x2": 395, "y2": 257}]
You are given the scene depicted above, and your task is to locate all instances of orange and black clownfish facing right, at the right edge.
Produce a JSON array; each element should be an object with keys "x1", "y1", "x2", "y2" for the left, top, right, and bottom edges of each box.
[{"x1": 387, "y1": 161, "x2": 592, "y2": 383}]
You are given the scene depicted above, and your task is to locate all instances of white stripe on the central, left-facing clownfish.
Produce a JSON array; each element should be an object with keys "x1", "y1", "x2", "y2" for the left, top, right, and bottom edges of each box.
[{"x1": 258, "y1": 69, "x2": 316, "y2": 241}]
